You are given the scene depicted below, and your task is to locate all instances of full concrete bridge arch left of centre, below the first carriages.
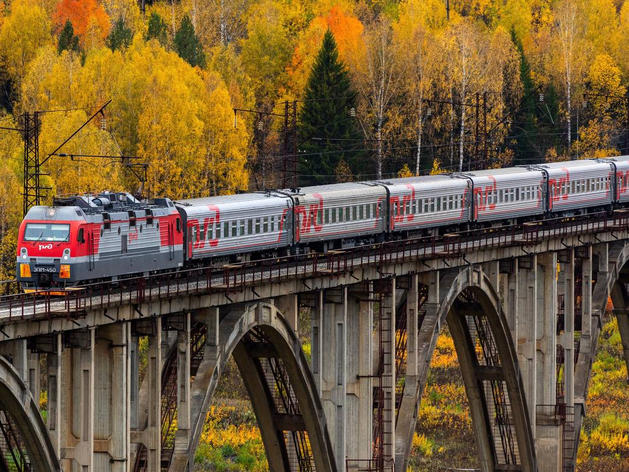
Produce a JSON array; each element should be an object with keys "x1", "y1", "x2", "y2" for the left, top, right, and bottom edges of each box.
[{"x1": 170, "y1": 303, "x2": 336, "y2": 472}]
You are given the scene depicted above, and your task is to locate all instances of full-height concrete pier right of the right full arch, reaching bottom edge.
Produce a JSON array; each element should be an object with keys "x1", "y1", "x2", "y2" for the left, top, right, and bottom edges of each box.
[{"x1": 534, "y1": 252, "x2": 562, "y2": 472}]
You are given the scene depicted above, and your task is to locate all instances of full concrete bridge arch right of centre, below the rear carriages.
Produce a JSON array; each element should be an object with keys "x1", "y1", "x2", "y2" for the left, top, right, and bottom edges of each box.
[{"x1": 396, "y1": 267, "x2": 537, "y2": 471}]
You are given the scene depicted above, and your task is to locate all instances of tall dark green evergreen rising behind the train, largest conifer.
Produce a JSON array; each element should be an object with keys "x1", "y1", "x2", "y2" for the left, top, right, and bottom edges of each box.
[{"x1": 299, "y1": 30, "x2": 364, "y2": 185}]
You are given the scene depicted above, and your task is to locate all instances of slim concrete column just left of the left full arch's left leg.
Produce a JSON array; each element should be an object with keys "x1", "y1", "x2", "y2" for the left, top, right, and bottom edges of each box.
[{"x1": 175, "y1": 313, "x2": 191, "y2": 452}]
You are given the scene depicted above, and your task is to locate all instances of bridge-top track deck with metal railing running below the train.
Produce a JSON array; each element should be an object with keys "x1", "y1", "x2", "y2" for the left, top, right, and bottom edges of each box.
[{"x1": 0, "y1": 210, "x2": 629, "y2": 322}]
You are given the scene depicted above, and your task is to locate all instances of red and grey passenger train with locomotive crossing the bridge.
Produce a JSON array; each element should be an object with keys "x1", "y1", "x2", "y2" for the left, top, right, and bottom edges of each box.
[{"x1": 16, "y1": 156, "x2": 629, "y2": 292}]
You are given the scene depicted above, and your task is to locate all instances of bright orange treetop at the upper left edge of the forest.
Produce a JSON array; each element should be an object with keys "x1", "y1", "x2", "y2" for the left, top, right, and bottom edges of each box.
[{"x1": 53, "y1": 0, "x2": 109, "y2": 39}]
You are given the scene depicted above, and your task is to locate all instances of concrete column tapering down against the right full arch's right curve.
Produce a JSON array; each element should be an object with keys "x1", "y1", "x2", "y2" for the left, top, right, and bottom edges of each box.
[{"x1": 515, "y1": 255, "x2": 538, "y2": 437}]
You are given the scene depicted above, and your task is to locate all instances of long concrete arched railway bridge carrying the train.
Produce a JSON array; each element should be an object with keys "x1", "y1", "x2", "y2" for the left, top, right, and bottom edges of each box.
[{"x1": 0, "y1": 210, "x2": 629, "y2": 472}]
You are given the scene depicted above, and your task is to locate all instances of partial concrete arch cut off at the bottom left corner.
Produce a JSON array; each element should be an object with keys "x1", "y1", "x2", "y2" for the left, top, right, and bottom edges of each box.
[{"x1": 0, "y1": 356, "x2": 61, "y2": 472}]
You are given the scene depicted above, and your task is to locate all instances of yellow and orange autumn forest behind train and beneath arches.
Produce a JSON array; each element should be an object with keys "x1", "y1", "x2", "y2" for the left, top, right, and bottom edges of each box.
[{"x1": 0, "y1": 0, "x2": 629, "y2": 471}]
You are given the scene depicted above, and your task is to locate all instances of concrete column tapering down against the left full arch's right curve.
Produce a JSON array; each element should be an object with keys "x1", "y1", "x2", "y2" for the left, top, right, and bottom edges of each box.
[{"x1": 320, "y1": 287, "x2": 347, "y2": 472}]
